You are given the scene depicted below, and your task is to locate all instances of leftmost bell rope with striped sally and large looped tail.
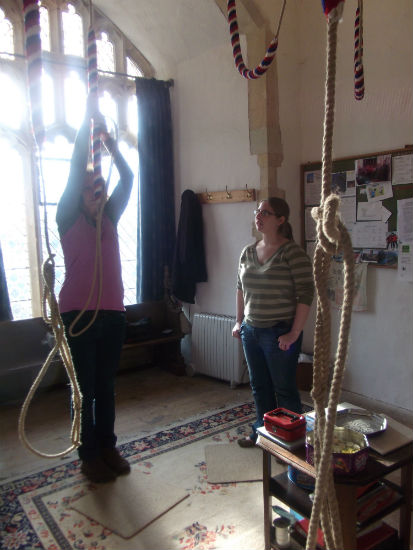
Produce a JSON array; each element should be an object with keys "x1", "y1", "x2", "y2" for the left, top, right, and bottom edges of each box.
[{"x1": 18, "y1": 0, "x2": 82, "y2": 458}]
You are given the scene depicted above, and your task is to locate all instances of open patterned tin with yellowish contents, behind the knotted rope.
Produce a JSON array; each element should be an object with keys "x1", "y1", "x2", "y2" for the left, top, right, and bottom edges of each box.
[{"x1": 306, "y1": 426, "x2": 369, "y2": 475}]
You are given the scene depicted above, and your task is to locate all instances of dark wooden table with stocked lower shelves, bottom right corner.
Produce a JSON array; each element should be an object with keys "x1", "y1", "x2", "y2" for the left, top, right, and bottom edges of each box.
[{"x1": 257, "y1": 428, "x2": 413, "y2": 550}]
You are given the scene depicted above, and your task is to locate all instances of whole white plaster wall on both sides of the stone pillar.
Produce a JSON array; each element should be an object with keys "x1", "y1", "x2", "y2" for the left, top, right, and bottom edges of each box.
[{"x1": 173, "y1": 0, "x2": 413, "y2": 411}]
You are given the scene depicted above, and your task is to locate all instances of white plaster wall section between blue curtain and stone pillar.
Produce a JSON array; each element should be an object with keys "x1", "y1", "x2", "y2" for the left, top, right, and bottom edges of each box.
[{"x1": 173, "y1": 40, "x2": 259, "y2": 315}]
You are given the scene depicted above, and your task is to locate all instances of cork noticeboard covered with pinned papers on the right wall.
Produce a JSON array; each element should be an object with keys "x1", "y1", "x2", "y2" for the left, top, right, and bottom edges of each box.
[{"x1": 301, "y1": 145, "x2": 413, "y2": 268}]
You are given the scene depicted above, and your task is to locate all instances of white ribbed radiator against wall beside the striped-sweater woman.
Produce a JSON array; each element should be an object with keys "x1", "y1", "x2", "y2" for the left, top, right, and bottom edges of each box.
[{"x1": 192, "y1": 313, "x2": 248, "y2": 387}]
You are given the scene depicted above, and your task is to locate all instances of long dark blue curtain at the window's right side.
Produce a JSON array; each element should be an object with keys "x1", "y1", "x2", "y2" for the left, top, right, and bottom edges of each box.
[{"x1": 136, "y1": 78, "x2": 175, "y2": 302}]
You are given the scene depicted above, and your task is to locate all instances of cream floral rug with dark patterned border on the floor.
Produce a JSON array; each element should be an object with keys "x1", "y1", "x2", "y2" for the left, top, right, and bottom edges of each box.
[{"x1": 0, "y1": 403, "x2": 270, "y2": 550}]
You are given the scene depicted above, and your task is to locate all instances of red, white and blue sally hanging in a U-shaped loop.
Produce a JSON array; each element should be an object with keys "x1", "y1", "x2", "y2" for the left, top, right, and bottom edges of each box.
[{"x1": 227, "y1": 0, "x2": 286, "y2": 80}]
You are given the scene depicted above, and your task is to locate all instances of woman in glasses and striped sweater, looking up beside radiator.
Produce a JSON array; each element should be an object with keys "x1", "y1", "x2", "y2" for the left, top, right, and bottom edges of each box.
[{"x1": 232, "y1": 197, "x2": 314, "y2": 447}]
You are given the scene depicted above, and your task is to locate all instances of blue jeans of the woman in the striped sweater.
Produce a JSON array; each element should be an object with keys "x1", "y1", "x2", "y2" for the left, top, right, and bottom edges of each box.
[{"x1": 240, "y1": 321, "x2": 303, "y2": 440}]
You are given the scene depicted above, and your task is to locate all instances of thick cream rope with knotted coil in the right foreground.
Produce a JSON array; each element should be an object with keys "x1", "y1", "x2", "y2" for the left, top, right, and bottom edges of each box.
[{"x1": 306, "y1": 1, "x2": 354, "y2": 550}]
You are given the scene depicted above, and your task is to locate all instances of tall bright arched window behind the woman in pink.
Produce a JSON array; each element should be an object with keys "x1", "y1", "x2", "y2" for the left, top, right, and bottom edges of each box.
[{"x1": 0, "y1": 0, "x2": 144, "y2": 320}]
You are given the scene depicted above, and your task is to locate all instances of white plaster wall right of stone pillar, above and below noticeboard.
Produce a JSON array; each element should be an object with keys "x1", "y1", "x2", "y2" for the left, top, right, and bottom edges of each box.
[{"x1": 290, "y1": 0, "x2": 413, "y2": 411}]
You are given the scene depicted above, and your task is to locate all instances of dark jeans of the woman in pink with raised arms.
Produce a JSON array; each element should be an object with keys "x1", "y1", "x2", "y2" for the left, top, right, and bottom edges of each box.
[{"x1": 61, "y1": 310, "x2": 126, "y2": 460}]
